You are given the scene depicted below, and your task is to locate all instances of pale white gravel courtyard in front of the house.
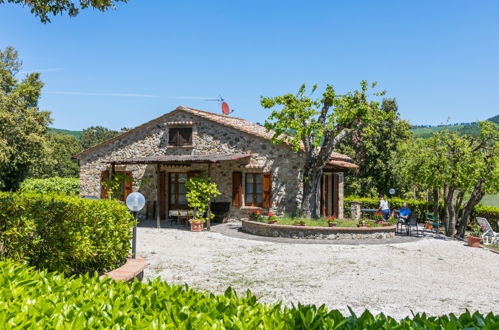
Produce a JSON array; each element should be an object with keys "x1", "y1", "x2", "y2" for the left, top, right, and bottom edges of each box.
[{"x1": 137, "y1": 225, "x2": 499, "y2": 318}]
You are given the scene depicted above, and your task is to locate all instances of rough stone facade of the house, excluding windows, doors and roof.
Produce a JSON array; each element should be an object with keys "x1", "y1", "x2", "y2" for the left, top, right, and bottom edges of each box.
[{"x1": 80, "y1": 110, "x2": 343, "y2": 217}]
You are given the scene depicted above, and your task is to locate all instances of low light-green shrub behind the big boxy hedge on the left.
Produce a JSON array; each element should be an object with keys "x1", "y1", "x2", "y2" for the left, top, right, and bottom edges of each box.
[{"x1": 19, "y1": 177, "x2": 80, "y2": 196}]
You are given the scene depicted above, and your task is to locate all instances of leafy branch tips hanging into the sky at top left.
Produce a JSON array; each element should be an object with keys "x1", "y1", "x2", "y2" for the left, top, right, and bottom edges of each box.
[{"x1": 0, "y1": 0, "x2": 128, "y2": 23}]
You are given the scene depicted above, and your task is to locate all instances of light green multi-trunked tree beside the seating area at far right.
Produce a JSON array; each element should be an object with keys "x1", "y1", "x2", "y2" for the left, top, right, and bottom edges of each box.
[{"x1": 399, "y1": 122, "x2": 499, "y2": 236}]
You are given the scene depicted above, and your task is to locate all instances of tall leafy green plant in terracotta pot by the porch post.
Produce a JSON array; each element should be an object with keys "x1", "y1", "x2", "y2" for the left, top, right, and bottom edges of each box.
[{"x1": 185, "y1": 176, "x2": 221, "y2": 232}]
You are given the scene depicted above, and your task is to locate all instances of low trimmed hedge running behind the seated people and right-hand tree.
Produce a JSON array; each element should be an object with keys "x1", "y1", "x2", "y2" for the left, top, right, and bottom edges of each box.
[{"x1": 344, "y1": 196, "x2": 499, "y2": 226}]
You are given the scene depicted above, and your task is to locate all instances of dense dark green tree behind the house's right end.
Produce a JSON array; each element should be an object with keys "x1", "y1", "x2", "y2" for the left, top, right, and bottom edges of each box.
[{"x1": 337, "y1": 98, "x2": 411, "y2": 197}]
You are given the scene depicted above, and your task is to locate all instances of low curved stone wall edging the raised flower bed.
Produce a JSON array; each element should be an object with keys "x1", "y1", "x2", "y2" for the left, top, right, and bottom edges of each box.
[{"x1": 242, "y1": 220, "x2": 396, "y2": 240}]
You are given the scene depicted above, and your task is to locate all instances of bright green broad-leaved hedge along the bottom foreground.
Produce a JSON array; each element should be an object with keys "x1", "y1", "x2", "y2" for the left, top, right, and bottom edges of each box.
[{"x1": 0, "y1": 262, "x2": 499, "y2": 329}]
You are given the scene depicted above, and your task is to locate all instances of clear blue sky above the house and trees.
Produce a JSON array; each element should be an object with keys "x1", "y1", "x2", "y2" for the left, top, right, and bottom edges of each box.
[{"x1": 0, "y1": 0, "x2": 499, "y2": 129}]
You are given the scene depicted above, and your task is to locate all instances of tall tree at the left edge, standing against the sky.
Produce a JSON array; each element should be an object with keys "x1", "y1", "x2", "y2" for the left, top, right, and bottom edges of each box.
[{"x1": 0, "y1": 47, "x2": 50, "y2": 190}]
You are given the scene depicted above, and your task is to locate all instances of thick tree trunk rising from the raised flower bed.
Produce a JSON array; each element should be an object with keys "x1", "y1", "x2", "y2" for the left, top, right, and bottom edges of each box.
[{"x1": 301, "y1": 167, "x2": 322, "y2": 219}]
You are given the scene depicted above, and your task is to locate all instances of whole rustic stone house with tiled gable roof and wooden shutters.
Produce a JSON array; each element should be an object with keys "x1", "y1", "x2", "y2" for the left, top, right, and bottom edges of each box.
[{"x1": 75, "y1": 106, "x2": 357, "y2": 220}]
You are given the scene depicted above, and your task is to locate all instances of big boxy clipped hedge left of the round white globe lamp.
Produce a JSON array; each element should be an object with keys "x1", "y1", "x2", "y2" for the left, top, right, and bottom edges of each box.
[{"x1": 0, "y1": 193, "x2": 134, "y2": 274}]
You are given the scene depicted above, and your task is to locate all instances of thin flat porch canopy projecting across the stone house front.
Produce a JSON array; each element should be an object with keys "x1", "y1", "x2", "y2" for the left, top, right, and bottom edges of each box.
[{"x1": 106, "y1": 154, "x2": 251, "y2": 165}]
